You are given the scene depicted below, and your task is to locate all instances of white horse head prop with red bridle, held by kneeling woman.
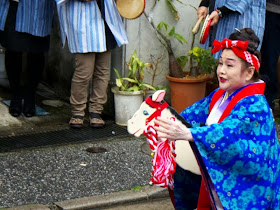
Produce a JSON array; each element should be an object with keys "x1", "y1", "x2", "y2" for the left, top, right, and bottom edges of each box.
[{"x1": 127, "y1": 90, "x2": 200, "y2": 174}]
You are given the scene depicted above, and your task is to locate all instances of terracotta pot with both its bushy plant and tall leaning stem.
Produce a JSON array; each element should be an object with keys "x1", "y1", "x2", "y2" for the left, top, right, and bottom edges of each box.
[{"x1": 145, "y1": 2, "x2": 216, "y2": 112}]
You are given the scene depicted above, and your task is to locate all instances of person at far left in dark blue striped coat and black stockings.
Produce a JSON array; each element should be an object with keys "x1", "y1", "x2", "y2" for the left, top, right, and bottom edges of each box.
[{"x1": 0, "y1": 0, "x2": 55, "y2": 117}]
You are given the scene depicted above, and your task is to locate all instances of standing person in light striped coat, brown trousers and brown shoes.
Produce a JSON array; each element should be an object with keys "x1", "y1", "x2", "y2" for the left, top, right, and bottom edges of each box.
[{"x1": 56, "y1": 0, "x2": 128, "y2": 128}]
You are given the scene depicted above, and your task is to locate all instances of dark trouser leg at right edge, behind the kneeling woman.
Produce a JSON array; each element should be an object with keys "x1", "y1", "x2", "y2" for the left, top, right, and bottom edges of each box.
[{"x1": 260, "y1": 11, "x2": 280, "y2": 109}]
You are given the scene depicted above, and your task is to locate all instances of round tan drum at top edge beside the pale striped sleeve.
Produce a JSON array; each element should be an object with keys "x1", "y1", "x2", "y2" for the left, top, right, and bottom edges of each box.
[{"x1": 116, "y1": 0, "x2": 145, "y2": 19}]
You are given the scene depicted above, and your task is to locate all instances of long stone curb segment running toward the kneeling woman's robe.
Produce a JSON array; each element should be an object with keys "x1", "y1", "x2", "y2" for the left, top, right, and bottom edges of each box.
[{"x1": 54, "y1": 186, "x2": 169, "y2": 210}]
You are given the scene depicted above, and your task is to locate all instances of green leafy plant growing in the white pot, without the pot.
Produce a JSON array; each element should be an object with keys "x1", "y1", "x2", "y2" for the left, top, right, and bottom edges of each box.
[{"x1": 114, "y1": 50, "x2": 158, "y2": 91}]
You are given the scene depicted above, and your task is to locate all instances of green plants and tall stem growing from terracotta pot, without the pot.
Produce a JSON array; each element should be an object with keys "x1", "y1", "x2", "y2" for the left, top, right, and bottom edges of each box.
[{"x1": 144, "y1": 0, "x2": 217, "y2": 78}]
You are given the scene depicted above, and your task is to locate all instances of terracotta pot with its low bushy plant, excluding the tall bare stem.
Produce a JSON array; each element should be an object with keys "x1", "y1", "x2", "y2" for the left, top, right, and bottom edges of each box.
[{"x1": 166, "y1": 40, "x2": 218, "y2": 112}]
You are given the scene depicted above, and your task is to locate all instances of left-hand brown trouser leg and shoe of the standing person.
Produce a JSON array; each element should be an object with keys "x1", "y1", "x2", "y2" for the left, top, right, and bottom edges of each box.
[{"x1": 69, "y1": 53, "x2": 95, "y2": 127}]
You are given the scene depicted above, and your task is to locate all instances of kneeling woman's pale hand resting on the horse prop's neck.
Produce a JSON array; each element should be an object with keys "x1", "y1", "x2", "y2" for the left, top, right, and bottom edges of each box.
[{"x1": 154, "y1": 117, "x2": 193, "y2": 141}]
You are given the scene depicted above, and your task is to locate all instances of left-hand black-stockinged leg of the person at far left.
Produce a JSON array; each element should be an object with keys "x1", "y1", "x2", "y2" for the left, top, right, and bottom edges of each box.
[{"x1": 5, "y1": 49, "x2": 22, "y2": 117}]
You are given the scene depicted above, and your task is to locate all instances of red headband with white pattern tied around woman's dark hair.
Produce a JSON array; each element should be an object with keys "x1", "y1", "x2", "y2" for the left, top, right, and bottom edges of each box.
[{"x1": 212, "y1": 39, "x2": 260, "y2": 71}]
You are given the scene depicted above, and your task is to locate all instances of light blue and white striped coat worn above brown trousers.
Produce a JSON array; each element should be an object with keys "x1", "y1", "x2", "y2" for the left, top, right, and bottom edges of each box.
[{"x1": 56, "y1": 0, "x2": 128, "y2": 53}]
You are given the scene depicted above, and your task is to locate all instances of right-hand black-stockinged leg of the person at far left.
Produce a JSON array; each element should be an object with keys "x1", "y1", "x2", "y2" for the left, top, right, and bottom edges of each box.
[{"x1": 23, "y1": 52, "x2": 45, "y2": 117}]
